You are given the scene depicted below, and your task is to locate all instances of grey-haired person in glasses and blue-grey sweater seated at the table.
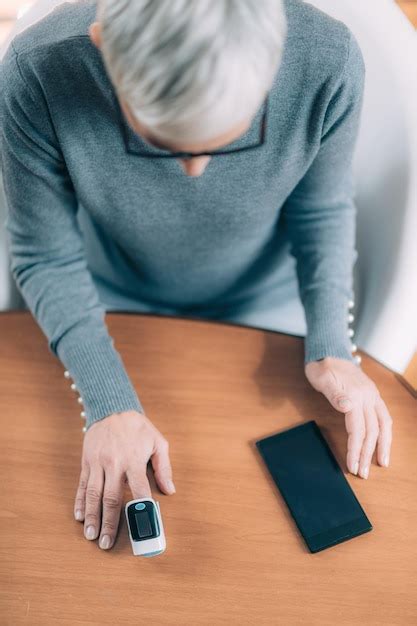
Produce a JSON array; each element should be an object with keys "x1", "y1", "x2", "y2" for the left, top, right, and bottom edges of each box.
[{"x1": 0, "y1": 0, "x2": 392, "y2": 549}]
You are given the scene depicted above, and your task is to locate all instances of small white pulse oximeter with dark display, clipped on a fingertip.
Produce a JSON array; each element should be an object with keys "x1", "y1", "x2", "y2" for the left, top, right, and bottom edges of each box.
[{"x1": 125, "y1": 498, "x2": 166, "y2": 556}]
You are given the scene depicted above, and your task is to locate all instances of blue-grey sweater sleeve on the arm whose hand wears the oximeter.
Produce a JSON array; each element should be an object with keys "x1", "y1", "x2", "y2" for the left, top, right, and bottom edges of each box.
[{"x1": 0, "y1": 44, "x2": 144, "y2": 429}]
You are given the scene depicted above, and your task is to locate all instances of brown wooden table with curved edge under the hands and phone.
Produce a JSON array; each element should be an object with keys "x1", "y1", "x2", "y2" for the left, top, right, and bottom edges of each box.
[{"x1": 0, "y1": 311, "x2": 417, "y2": 626}]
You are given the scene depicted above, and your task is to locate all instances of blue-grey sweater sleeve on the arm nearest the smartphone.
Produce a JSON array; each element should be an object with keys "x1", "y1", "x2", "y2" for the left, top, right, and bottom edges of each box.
[{"x1": 283, "y1": 31, "x2": 365, "y2": 364}]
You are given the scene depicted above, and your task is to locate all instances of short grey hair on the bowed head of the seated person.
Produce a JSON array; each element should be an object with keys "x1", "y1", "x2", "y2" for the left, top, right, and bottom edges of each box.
[{"x1": 97, "y1": 0, "x2": 287, "y2": 142}]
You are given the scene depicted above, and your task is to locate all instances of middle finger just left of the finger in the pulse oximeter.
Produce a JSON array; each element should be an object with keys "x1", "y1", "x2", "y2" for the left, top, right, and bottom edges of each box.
[{"x1": 99, "y1": 467, "x2": 124, "y2": 550}]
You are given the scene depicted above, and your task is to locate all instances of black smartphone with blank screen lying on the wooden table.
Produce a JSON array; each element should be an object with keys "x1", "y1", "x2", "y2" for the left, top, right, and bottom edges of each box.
[{"x1": 255, "y1": 420, "x2": 372, "y2": 552}]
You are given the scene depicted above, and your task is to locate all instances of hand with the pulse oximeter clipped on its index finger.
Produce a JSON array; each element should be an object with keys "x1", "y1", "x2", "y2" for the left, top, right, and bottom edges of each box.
[{"x1": 74, "y1": 410, "x2": 175, "y2": 549}]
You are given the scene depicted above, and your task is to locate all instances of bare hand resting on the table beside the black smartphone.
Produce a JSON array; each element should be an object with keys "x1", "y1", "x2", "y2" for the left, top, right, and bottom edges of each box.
[{"x1": 304, "y1": 357, "x2": 392, "y2": 478}]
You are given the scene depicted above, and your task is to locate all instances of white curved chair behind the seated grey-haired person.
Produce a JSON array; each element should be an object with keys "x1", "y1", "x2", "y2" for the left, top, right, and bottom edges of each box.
[{"x1": 0, "y1": 0, "x2": 417, "y2": 373}]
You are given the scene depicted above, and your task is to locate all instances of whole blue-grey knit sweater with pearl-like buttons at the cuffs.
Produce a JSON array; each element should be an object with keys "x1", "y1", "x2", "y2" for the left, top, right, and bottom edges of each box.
[{"x1": 0, "y1": 0, "x2": 365, "y2": 428}]
